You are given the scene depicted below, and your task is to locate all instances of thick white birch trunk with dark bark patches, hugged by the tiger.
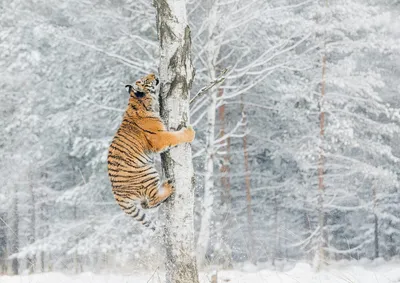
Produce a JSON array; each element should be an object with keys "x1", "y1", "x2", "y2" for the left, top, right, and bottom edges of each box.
[{"x1": 154, "y1": 0, "x2": 199, "y2": 283}]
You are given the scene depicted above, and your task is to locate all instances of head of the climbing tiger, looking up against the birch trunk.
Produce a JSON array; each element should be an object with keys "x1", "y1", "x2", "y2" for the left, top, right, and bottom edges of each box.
[{"x1": 125, "y1": 74, "x2": 159, "y2": 111}]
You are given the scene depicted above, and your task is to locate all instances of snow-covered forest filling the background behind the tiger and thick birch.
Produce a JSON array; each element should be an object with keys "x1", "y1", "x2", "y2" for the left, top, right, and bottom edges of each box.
[{"x1": 0, "y1": 0, "x2": 400, "y2": 274}]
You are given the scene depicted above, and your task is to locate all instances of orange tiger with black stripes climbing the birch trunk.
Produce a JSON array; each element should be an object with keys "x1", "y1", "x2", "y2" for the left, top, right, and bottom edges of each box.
[{"x1": 108, "y1": 74, "x2": 195, "y2": 231}]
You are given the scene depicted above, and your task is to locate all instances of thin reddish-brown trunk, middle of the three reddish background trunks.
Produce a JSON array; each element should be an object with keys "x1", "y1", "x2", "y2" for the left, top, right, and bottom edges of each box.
[{"x1": 240, "y1": 96, "x2": 256, "y2": 264}]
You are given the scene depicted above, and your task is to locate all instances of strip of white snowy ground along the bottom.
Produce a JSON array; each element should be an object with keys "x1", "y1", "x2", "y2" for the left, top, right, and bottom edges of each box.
[{"x1": 0, "y1": 263, "x2": 400, "y2": 283}]
